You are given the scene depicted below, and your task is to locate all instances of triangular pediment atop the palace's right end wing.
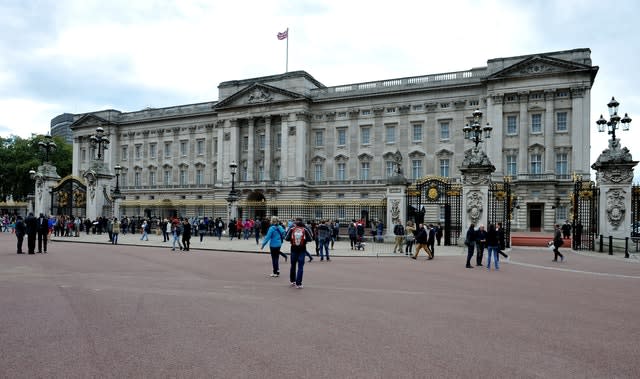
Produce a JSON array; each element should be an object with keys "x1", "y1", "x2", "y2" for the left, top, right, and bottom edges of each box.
[{"x1": 487, "y1": 55, "x2": 598, "y2": 80}]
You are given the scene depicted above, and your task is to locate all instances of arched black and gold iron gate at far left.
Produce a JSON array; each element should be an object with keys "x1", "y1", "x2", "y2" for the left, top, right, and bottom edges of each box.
[{"x1": 51, "y1": 176, "x2": 87, "y2": 217}]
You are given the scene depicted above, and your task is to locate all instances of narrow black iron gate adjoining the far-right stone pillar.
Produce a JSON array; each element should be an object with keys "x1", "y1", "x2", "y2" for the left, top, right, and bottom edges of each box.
[{"x1": 571, "y1": 179, "x2": 600, "y2": 250}]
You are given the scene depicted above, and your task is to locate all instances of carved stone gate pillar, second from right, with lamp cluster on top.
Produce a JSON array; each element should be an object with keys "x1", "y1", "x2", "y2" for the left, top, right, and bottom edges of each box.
[{"x1": 458, "y1": 147, "x2": 496, "y2": 244}]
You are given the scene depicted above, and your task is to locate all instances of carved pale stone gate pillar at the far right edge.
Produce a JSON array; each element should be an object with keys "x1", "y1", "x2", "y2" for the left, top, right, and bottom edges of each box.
[{"x1": 591, "y1": 138, "x2": 638, "y2": 238}]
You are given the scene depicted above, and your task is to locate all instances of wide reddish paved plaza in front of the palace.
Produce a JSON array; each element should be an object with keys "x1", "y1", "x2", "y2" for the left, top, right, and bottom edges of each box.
[{"x1": 0, "y1": 233, "x2": 640, "y2": 378}]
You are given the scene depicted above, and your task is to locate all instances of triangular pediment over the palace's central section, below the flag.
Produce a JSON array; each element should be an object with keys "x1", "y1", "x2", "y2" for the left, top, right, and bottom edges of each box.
[{"x1": 213, "y1": 83, "x2": 307, "y2": 109}]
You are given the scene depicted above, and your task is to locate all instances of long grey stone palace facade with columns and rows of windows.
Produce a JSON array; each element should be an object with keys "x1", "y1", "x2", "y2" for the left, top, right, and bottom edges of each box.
[{"x1": 70, "y1": 48, "x2": 598, "y2": 231}]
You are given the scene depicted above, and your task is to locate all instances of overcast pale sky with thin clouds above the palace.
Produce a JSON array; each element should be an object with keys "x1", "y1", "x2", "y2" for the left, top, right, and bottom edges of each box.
[{"x1": 0, "y1": 0, "x2": 640, "y2": 178}]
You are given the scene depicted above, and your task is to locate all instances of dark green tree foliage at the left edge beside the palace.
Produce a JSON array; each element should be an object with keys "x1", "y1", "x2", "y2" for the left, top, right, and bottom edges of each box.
[{"x1": 0, "y1": 135, "x2": 73, "y2": 201}]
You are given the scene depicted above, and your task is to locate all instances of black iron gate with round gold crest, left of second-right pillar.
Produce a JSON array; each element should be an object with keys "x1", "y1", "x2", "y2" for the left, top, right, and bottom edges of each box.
[{"x1": 407, "y1": 177, "x2": 462, "y2": 246}]
